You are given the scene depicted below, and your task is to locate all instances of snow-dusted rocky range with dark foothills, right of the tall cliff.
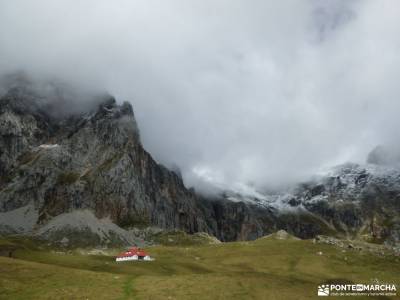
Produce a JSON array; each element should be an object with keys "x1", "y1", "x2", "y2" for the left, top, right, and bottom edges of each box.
[{"x1": 202, "y1": 163, "x2": 400, "y2": 247}]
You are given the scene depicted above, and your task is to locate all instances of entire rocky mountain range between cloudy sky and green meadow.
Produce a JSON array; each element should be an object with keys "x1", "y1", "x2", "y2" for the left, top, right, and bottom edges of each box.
[{"x1": 0, "y1": 84, "x2": 400, "y2": 245}]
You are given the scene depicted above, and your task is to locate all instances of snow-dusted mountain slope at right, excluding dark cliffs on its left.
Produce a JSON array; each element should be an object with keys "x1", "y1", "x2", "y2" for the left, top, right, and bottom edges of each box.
[{"x1": 217, "y1": 162, "x2": 400, "y2": 245}]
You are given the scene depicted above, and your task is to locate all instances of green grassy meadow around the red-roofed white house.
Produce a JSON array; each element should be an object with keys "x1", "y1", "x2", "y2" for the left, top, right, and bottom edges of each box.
[{"x1": 0, "y1": 237, "x2": 400, "y2": 300}]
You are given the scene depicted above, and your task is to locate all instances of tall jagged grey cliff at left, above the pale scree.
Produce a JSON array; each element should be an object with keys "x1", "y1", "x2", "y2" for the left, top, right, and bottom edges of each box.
[{"x1": 0, "y1": 82, "x2": 210, "y2": 237}]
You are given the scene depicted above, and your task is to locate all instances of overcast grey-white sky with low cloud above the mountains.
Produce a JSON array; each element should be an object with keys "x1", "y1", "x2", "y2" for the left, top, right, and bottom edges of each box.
[{"x1": 0, "y1": 0, "x2": 400, "y2": 191}]
